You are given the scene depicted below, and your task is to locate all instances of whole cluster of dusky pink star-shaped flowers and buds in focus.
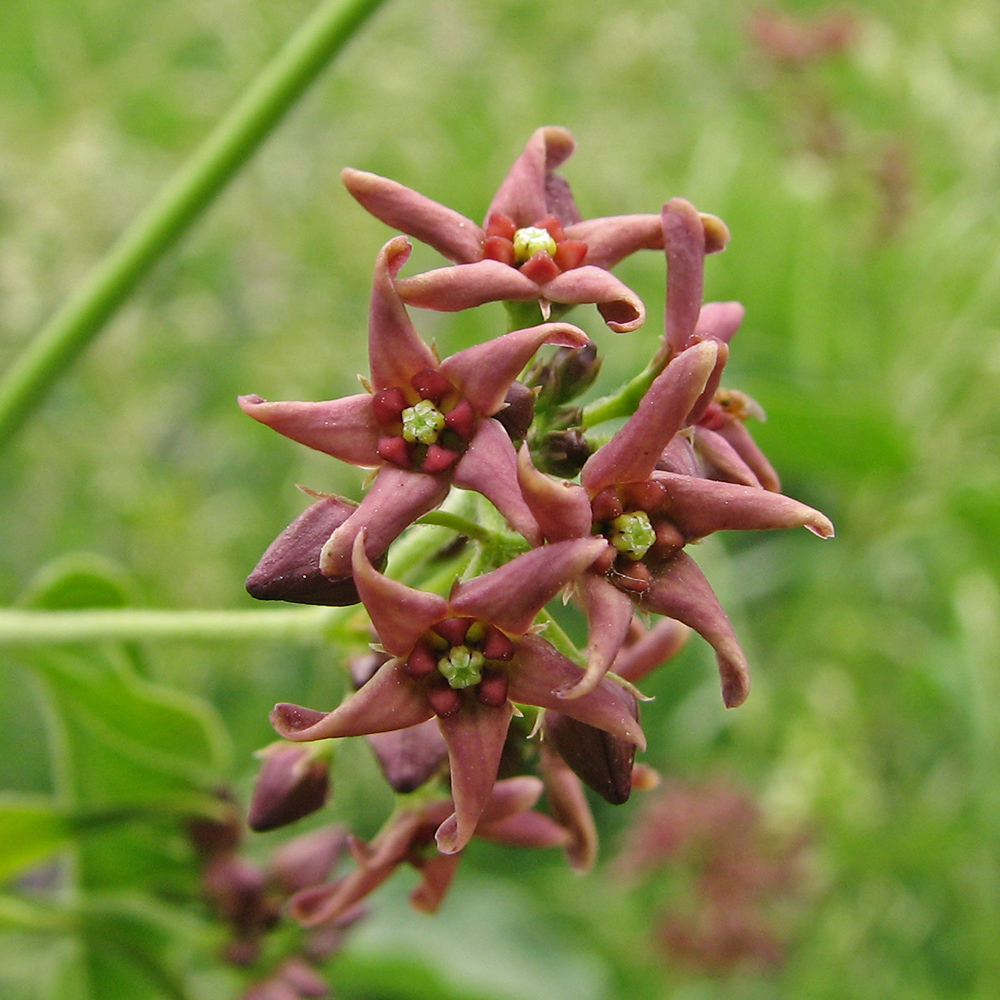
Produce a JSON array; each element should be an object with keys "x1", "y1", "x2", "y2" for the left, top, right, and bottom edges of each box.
[{"x1": 240, "y1": 127, "x2": 833, "y2": 924}]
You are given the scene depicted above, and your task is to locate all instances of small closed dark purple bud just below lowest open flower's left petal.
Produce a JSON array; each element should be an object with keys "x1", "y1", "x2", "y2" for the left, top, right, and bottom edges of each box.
[{"x1": 247, "y1": 743, "x2": 330, "y2": 833}]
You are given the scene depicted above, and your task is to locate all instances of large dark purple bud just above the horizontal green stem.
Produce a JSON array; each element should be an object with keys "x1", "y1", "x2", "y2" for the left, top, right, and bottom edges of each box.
[{"x1": 246, "y1": 496, "x2": 370, "y2": 607}]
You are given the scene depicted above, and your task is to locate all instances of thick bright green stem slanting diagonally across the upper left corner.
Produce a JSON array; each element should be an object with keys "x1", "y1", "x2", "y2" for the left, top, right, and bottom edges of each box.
[{"x1": 0, "y1": 0, "x2": 383, "y2": 442}]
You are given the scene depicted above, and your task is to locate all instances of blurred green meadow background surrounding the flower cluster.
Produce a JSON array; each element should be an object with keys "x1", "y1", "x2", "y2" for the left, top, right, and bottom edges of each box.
[{"x1": 0, "y1": 0, "x2": 1000, "y2": 1000}]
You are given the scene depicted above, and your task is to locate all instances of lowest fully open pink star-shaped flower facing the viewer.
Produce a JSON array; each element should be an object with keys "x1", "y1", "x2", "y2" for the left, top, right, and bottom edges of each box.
[{"x1": 271, "y1": 535, "x2": 644, "y2": 854}]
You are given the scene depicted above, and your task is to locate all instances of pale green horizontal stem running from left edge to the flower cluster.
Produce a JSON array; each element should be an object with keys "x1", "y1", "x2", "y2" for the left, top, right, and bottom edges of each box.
[{"x1": 0, "y1": 607, "x2": 358, "y2": 647}]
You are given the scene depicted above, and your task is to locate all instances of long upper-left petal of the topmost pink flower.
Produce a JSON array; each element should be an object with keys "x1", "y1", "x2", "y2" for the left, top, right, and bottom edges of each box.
[{"x1": 340, "y1": 167, "x2": 483, "y2": 264}]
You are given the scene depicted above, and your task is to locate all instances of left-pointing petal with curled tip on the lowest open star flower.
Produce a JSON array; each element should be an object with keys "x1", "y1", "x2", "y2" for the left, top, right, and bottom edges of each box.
[{"x1": 271, "y1": 660, "x2": 434, "y2": 743}]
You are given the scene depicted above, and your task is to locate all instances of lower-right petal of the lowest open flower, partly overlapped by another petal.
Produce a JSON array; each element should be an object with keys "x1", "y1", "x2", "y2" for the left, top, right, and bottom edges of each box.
[{"x1": 507, "y1": 635, "x2": 646, "y2": 750}]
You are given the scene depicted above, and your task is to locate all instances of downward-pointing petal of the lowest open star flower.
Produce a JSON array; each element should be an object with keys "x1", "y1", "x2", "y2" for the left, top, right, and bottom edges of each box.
[{"x1": 436, "y1": 699, "x2": 511, "y2": 854}]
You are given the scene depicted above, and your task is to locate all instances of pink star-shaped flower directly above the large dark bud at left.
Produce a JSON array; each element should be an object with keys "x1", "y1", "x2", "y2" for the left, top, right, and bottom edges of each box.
[{"x1": 240, "y1": 236, "x2": 589, "y2": 580}]
